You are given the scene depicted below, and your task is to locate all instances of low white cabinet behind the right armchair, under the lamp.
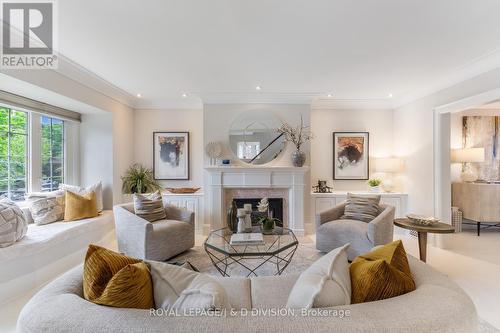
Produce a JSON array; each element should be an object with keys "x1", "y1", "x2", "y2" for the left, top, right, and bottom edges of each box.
[{"x1": 311, "y1": 191, "x2": 408, "y2": 221}]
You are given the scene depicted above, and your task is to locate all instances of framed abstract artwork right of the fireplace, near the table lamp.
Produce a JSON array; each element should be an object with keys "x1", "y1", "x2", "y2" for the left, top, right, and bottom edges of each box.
[{"x1": 333, "y1": 132, "x2": 370, "y2": 180}]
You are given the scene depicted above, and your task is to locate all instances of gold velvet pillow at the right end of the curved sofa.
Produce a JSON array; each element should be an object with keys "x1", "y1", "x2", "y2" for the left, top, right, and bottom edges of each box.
[{"x1": 350, "y1": 240, "x2": 416, "y2": 304}]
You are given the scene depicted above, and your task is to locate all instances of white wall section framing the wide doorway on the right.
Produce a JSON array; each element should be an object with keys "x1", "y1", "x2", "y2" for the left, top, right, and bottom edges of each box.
[{"x1": 394, "y1": 69, "x2": 500, "y2": 215}]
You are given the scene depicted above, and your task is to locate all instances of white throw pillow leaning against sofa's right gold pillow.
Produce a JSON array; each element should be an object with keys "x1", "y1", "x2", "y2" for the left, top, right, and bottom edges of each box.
[{"x1": 286, "y1": 244, "x2": 351, "y2": 309}]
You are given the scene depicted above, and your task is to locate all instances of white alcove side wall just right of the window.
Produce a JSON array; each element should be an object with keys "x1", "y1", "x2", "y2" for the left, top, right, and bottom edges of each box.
[{"x1": 80, "y1": 112, "x2": 113, "y2": 209}]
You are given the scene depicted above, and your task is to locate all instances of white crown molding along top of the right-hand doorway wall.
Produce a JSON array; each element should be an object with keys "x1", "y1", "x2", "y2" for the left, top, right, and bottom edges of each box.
[{"x1": 393, "y1": 48, "x2": 500, "y2": 108}]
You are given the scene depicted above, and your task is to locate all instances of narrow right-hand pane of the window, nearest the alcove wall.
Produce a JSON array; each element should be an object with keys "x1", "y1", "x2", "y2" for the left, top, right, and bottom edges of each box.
[{"x1": 40, "y1": 116, "x2": 64, "y2": 191}]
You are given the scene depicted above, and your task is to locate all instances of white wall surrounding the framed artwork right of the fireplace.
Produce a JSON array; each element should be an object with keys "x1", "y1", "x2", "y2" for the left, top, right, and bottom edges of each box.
[{"x1": 311, "y1": 105, "x2": 394, "y2": 190}]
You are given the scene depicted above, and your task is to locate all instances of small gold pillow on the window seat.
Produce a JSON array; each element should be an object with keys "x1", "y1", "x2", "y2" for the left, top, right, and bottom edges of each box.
[{"x1": 64, "y1": 191, "x2": 99, "y2": 222}]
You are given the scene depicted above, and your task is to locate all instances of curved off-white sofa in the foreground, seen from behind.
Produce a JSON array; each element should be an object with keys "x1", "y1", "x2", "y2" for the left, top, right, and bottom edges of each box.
[{"x1": 17, "y1": 257, "x2": 477, "y2": 333}]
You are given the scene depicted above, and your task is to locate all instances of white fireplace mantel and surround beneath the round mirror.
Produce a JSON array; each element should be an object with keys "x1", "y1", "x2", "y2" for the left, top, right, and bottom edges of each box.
[{"x1": 205, "y1": 166, "x2": 309, "y2": 235}]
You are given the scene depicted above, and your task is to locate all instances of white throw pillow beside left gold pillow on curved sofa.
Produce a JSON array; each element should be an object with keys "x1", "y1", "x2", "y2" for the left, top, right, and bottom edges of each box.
[{"x1": 148, "y1": 261, "x2": 231, "y2": 310}]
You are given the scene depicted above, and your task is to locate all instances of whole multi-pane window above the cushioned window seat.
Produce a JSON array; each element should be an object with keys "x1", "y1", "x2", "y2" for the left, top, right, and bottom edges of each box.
[{"x1": 0, "y1": 105, "x2": 66, "y2": 201}]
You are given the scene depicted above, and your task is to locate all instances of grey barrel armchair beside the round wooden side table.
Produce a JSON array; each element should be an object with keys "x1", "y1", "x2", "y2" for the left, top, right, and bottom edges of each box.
[{"x1": 316, "y1": 203, "x2": 395, "y2": 260}]
